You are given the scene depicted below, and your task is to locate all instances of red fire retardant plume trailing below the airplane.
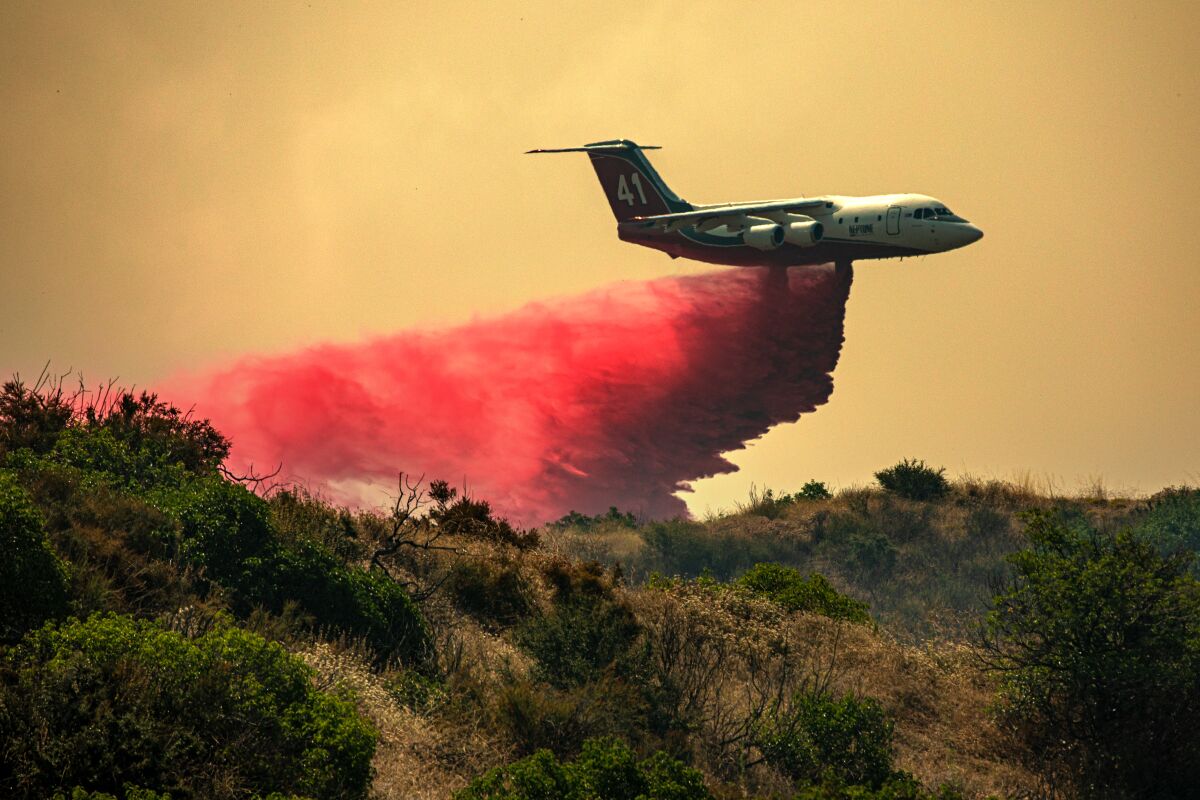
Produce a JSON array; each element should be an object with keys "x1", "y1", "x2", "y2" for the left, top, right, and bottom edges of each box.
[{"x1": 162, "y1": 266, "x2": 851, "y2": 525}]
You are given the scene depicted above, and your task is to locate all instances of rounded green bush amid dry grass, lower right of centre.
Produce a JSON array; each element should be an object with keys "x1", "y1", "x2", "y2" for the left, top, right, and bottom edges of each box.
[{"x1": 755, "y1": 692, "x2": 896, "y2": 789}]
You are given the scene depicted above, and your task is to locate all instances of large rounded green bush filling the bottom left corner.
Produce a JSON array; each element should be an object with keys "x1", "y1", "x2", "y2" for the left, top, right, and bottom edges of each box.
[{"x1": 0, "y1": 615, "x2": 376, "y2": 798}]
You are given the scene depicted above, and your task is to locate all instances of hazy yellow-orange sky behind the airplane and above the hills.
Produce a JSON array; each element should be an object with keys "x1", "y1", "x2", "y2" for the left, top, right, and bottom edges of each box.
[{"x1": 0, "y1": 0, "x2": 1200, "y2": 512}]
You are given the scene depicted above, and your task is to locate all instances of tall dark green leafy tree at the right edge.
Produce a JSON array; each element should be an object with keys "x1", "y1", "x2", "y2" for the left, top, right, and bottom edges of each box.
[{"x1": 984, "y1": 512, "x2": 1200, "y2": 798}]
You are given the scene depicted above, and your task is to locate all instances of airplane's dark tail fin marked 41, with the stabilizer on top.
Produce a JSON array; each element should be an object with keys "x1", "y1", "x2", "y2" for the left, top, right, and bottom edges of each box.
[{"x1": 528, "y1": 139, "x2": 692, "y2": 222}]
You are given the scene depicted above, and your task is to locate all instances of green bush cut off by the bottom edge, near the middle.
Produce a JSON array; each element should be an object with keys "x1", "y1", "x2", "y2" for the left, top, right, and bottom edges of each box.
[{"x1": 455, "y1": 738, "x2": 712, "y2": 800}]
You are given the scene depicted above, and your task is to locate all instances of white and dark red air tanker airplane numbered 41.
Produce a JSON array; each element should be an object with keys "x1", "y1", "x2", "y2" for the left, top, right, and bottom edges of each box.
[{"x1": 527, "y1": 139, "x2": 983, "y2": 267}]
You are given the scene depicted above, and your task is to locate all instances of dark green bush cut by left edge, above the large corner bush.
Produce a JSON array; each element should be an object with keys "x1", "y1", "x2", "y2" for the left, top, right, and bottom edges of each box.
[{"x1": 0, "y1": 470, "x2": 67, "y2": 642}]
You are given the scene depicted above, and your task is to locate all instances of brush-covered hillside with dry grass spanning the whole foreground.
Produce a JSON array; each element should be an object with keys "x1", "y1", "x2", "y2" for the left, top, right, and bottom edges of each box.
[{"x1": 0, "y1": 381, "x2": 1200, "y2": 799}]
